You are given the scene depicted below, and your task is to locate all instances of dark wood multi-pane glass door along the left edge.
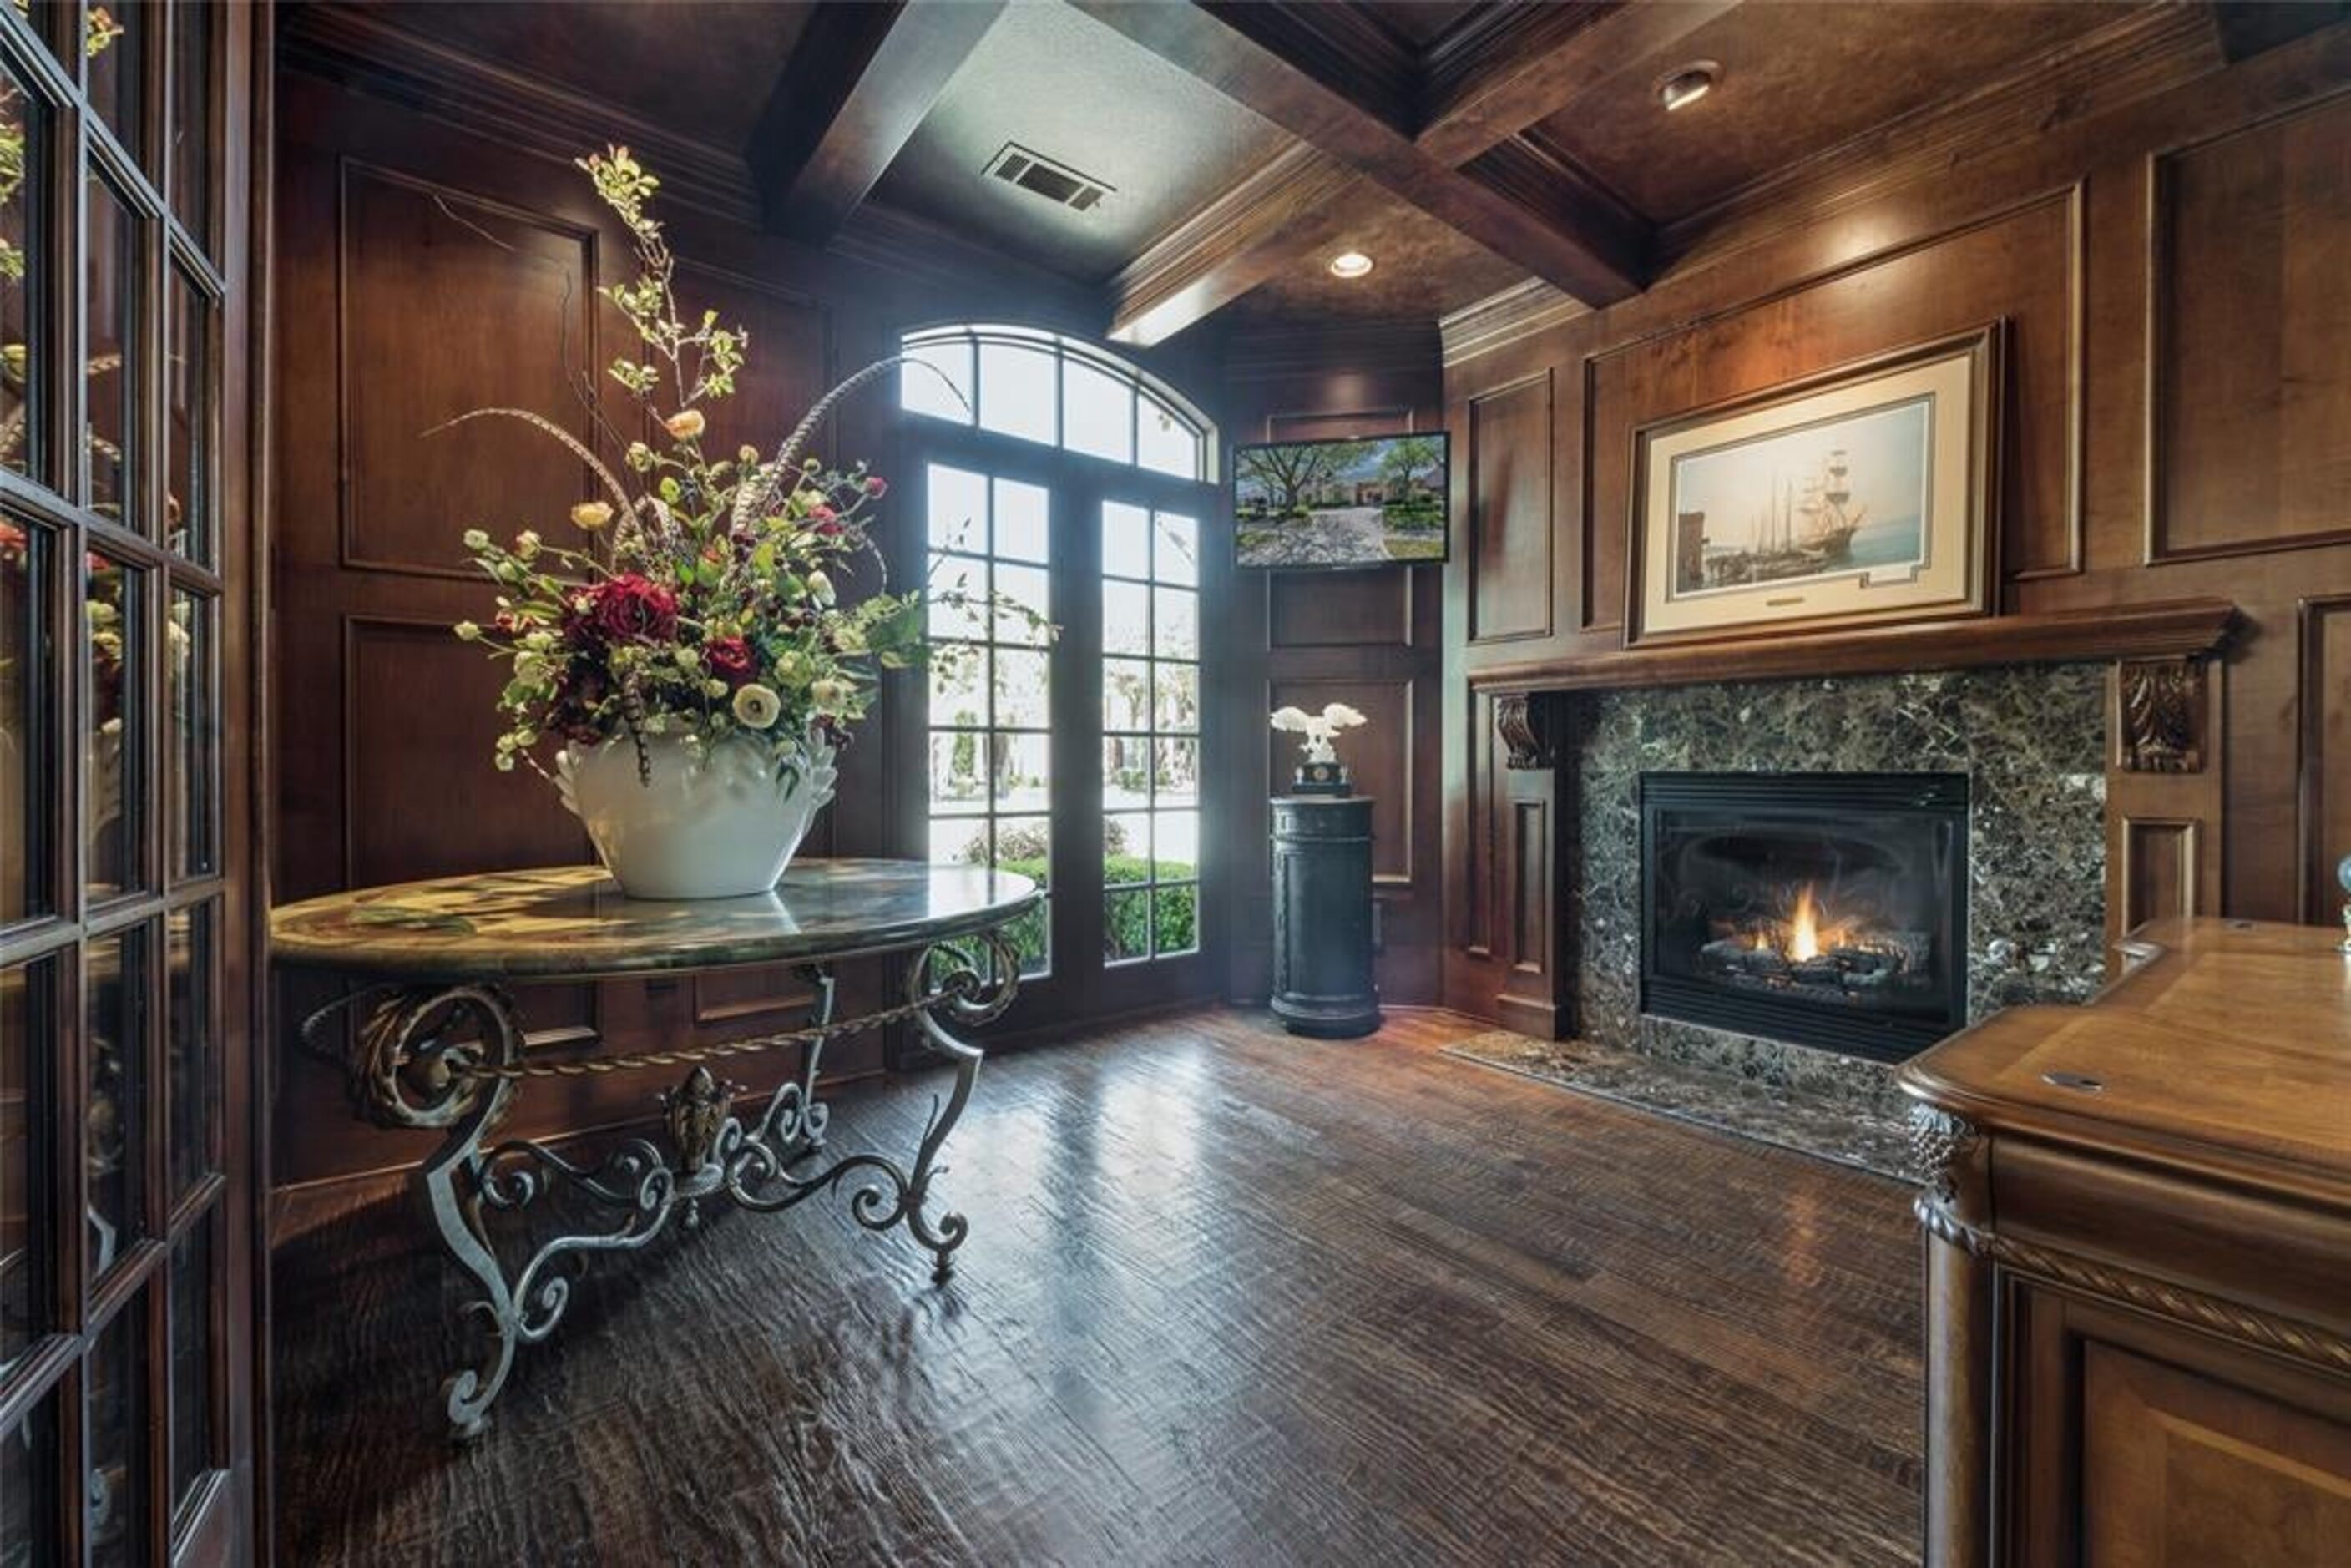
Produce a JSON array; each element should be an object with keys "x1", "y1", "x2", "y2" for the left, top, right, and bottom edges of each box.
[{"x1": 0, "y1": 0, "x2": 254, "y2": 1568}]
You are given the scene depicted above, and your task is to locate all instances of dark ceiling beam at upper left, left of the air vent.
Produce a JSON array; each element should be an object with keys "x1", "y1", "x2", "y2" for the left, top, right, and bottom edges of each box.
[{"x1": 746, "y1": 0, "x2": 1004, "y2": 245}]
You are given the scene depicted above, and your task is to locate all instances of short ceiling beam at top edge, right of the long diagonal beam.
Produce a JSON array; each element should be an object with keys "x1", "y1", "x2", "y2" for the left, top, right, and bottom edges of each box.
[{"x1": 1418, "y1": 0, "x2": 1740, "y2": 164}]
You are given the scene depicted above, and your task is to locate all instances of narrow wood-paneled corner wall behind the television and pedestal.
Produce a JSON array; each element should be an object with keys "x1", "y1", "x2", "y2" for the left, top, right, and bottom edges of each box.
[{"x1": 1211, "y1": 329, "x2": 1443, "y2": 1004}]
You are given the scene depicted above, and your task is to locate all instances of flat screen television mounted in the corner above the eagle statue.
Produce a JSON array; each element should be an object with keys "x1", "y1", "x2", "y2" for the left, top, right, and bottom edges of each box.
[{"x1": 1232, "y1": 430, "x2": 1450, "y2": 571}]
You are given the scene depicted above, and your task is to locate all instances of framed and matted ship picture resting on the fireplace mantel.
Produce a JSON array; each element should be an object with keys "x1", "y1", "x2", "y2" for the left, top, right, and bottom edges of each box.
[{"x1": 1625, "y1": 322, "x2": 2003, "y2": 644}]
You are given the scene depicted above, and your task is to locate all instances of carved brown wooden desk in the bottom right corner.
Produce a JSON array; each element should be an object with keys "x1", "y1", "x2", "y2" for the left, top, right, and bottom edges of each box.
[{"x1": 1902, "y1": 919, "x2": 2351, "y2": 1563}]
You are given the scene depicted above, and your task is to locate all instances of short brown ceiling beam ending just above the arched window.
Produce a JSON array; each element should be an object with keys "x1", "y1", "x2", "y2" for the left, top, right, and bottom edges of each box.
[{"x1": 1110, "y1": 141, "x2": 1368, "y2": 348}]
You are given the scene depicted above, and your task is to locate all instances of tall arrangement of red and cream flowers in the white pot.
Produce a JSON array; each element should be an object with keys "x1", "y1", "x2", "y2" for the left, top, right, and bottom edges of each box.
[{"x1": 452, "y1": 148, "x2": 1020, "y2": 783}]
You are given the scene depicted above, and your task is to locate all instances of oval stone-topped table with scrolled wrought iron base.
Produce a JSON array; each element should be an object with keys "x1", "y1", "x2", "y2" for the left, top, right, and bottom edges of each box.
[{"x1": 270, "y1": 861, "x2": 1044, "y2": 1439}]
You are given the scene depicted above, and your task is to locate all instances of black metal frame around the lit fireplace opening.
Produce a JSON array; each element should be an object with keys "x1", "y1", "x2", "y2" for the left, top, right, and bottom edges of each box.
[{"x1": 1639, "y1": 773, "x2": 1970, "y2": 1063}]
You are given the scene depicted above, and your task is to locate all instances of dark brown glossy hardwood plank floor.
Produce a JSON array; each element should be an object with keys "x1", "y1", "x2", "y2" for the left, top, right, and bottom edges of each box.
[{"x1": 275, "y1": 1011, "x2": 1921, "y2": 1568}]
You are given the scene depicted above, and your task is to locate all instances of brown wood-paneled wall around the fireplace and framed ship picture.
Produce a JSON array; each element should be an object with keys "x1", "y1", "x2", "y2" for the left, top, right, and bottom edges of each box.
[{"x1": 1443, "y1": 26, "x2": 2351, "y2": 1029}]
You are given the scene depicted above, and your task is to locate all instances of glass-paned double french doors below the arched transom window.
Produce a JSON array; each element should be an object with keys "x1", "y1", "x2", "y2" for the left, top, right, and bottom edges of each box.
[{"x1": 910, "y1": 338, "x2": 1218, "y2": 1027}]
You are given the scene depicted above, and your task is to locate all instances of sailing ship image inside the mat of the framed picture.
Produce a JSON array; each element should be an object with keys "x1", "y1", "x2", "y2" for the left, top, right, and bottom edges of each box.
[{"x1": 1669, "y1": 397, "x2": 1935, "y2": 597}]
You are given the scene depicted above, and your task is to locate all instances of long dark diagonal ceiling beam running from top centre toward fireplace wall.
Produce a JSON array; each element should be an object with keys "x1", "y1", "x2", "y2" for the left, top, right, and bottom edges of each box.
[{"x1": 1074, "y1": 0, "x2": 1648, "y2": 306}]
